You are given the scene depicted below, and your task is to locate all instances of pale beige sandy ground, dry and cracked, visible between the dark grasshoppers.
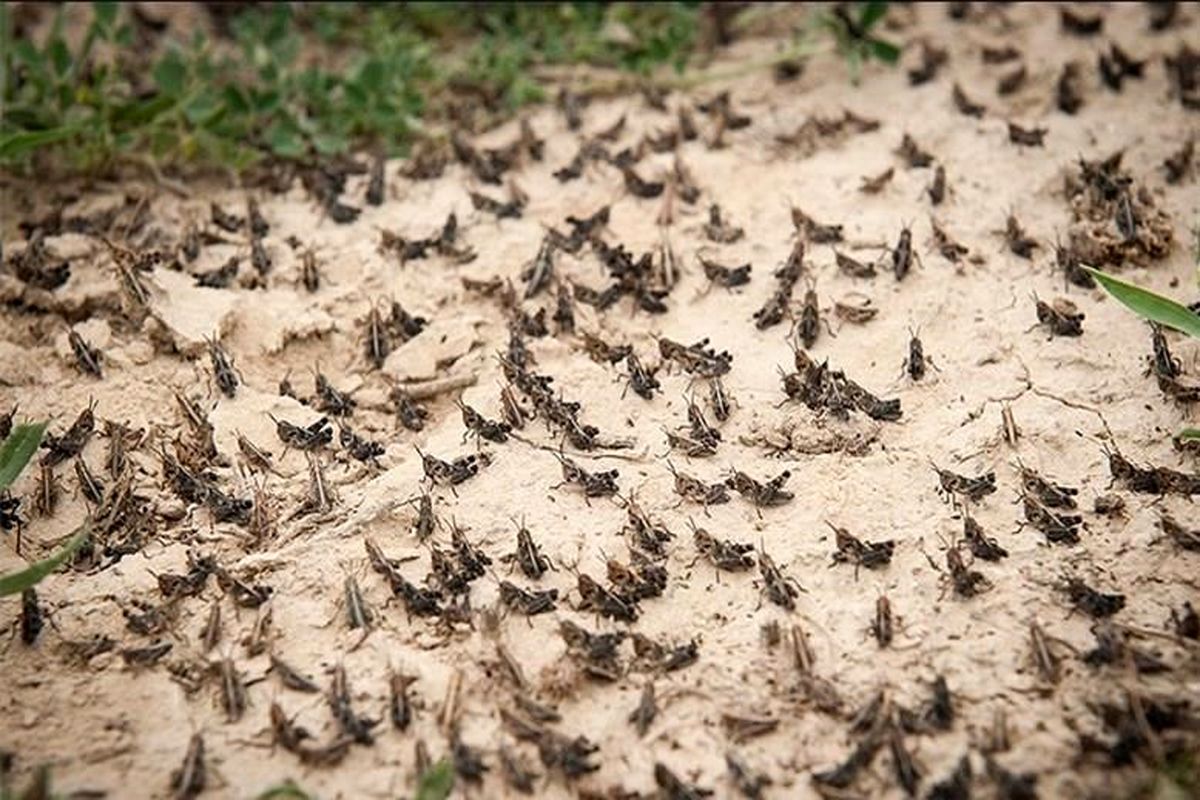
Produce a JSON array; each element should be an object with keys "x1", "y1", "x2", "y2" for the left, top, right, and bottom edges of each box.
[{"x1": 0, "y1": 5, "x2": 1200, "y2": 798}]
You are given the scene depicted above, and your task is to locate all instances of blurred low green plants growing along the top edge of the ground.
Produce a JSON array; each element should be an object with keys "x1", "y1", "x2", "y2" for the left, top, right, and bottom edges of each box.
[{"x1": 0, "y1": 2, "x2": 899, "y2": 175}]
